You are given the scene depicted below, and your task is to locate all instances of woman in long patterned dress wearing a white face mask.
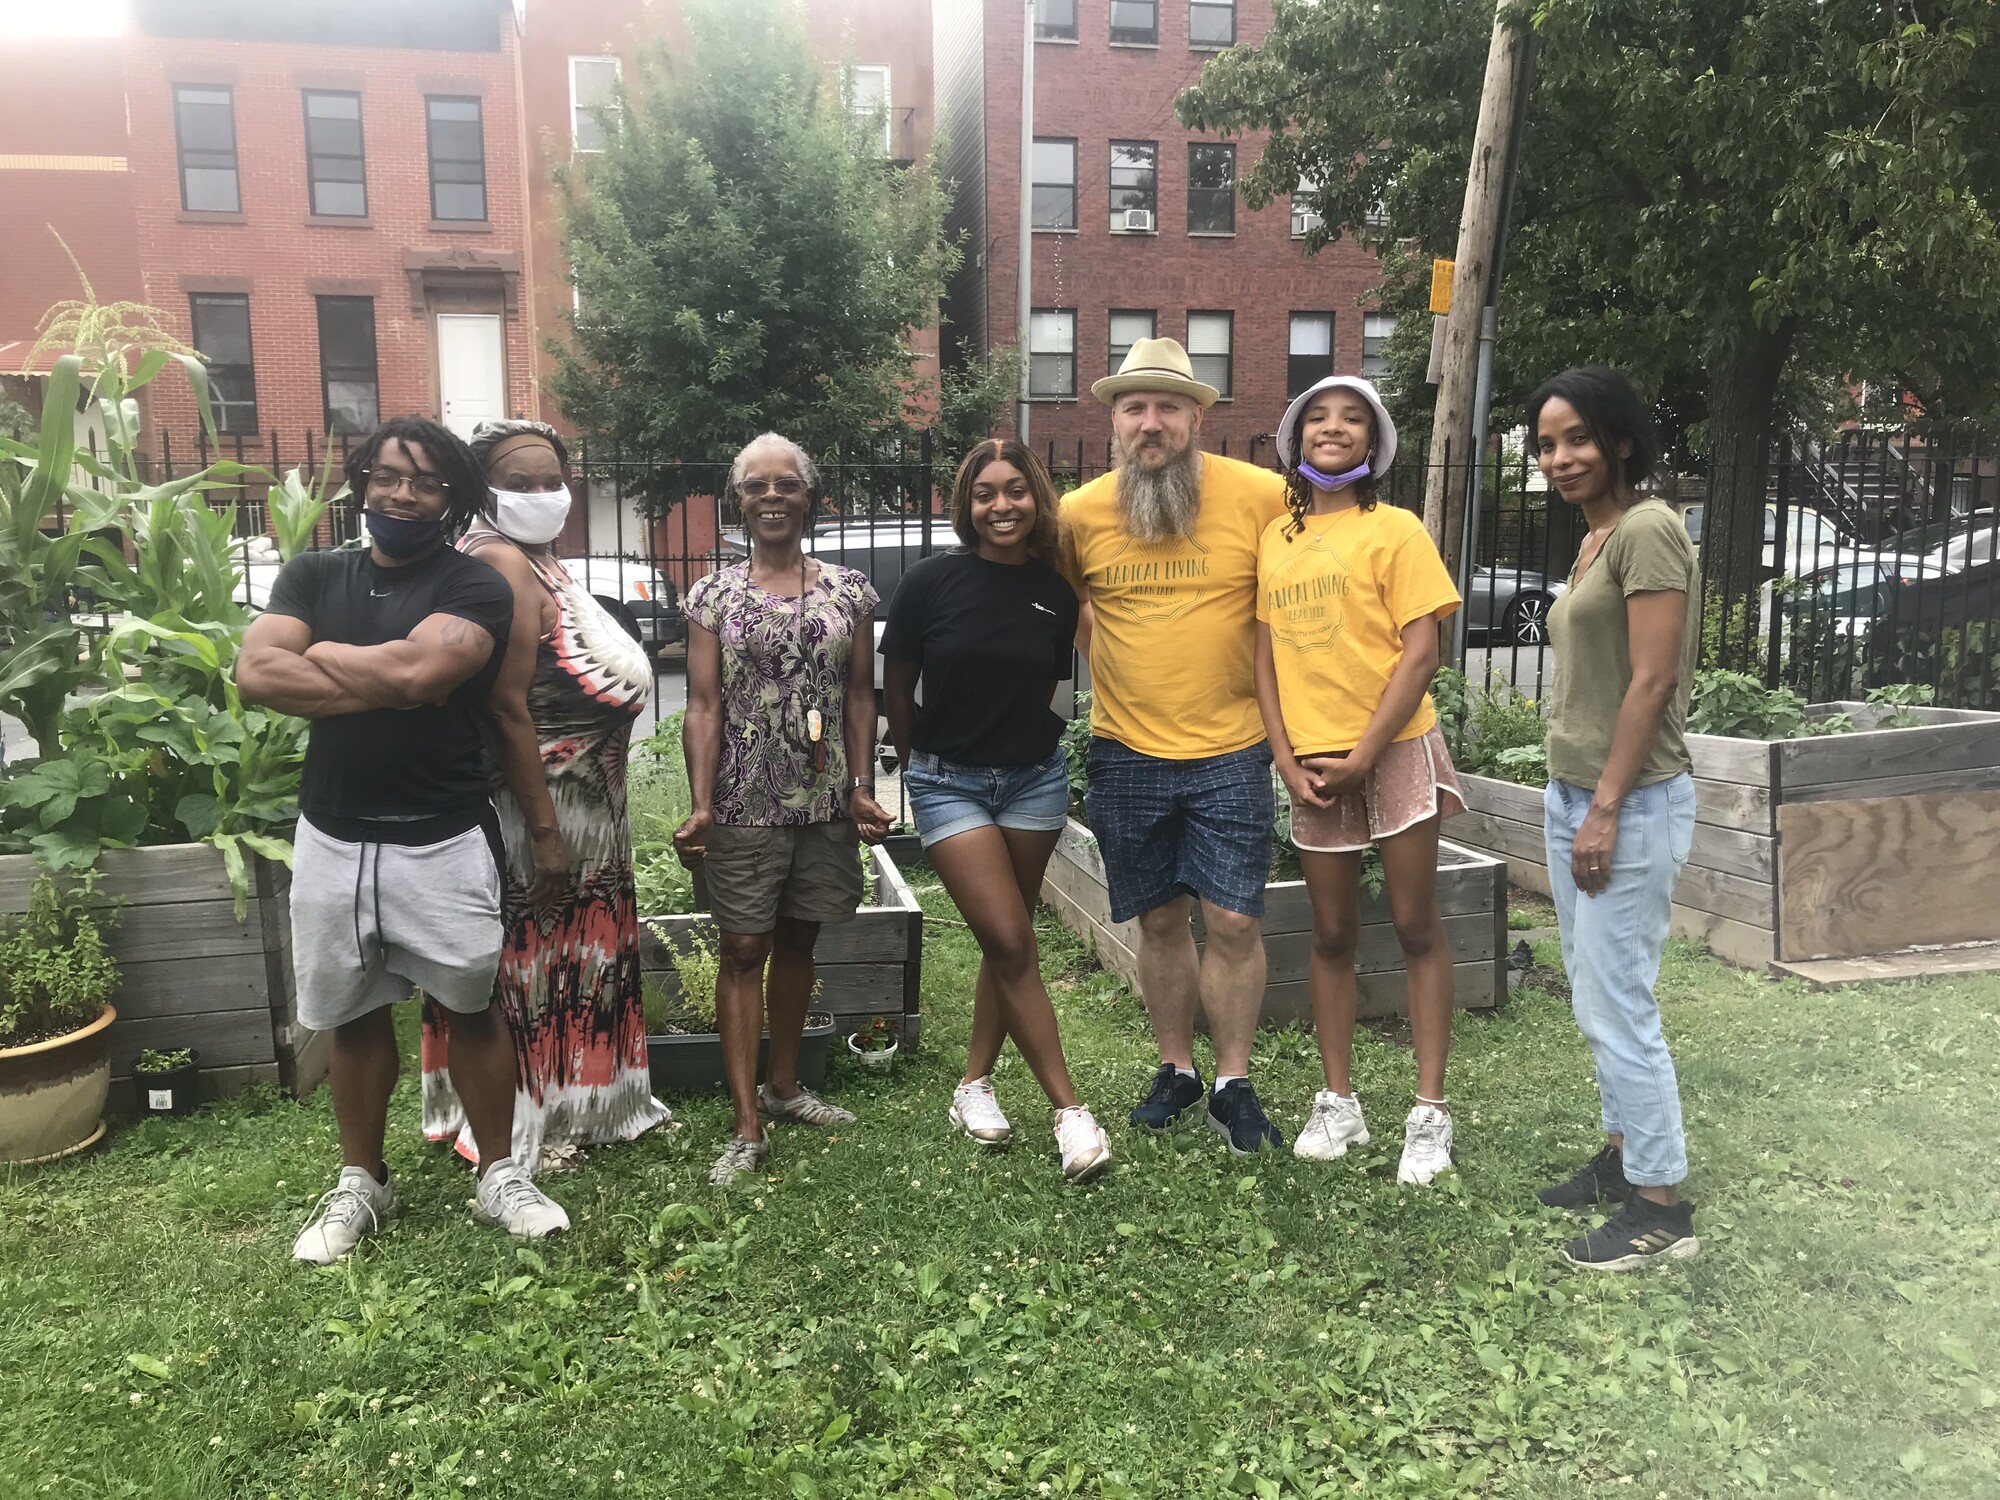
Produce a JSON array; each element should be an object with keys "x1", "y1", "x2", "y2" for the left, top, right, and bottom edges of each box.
[{"x1": 422, "y1": 422, "x2": 672, "y2": 1170}]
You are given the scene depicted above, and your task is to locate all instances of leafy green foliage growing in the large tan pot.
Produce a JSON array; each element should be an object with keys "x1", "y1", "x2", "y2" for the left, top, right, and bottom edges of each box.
[{"x1": 0, "y1": 874, "x2": 118, "y2": 1046}]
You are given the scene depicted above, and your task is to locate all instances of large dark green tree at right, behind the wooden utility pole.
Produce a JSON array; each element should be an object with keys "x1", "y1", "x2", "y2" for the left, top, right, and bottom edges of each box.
[{"x1": 1180, "y1": 0, "x2": 2000, "y2": 612}]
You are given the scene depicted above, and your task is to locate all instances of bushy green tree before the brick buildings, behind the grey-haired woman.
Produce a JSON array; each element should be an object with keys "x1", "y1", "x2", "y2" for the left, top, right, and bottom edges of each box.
[{"x1": 552, "y1": 0, "x2": 956, "y2": 478}]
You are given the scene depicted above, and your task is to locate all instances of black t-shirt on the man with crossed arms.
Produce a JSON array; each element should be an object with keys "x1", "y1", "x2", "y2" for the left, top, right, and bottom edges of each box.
[{"x1": 266, "y1": 546, "x2": 514, "y2": 836}]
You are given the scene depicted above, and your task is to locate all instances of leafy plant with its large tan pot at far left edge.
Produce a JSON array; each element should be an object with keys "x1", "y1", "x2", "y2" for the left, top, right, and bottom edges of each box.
[{"x1": 0, "y1": 876, "x2": 118, "y2": 1162}]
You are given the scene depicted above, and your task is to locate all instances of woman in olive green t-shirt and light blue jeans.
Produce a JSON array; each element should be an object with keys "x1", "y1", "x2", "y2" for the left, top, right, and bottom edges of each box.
[{"x1": 1528, "y1": 368, "x2": 1700, "y2": 1270}]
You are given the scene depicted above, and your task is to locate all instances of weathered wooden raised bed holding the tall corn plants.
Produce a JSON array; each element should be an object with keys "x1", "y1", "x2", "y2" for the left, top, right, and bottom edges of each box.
[{"x1": 0, "y1": 844, "x2": 330, "y2": 1098}]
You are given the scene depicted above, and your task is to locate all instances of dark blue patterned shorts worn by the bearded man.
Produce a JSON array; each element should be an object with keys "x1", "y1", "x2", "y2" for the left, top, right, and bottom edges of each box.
[{"x1": 1086, "y1": 738, "x2": 1276, "y2": 922}]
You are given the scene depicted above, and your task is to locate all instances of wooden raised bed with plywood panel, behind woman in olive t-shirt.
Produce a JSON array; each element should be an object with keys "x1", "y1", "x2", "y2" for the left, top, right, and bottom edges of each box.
[{"x1": 1446, "y1": 702, "x2": 2000, "y2": 966}]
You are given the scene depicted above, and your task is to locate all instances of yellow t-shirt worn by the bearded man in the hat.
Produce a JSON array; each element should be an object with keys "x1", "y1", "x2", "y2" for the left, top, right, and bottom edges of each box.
[{"x1": 1062, "y1": 454, "x2": 1284, "y2": 760}]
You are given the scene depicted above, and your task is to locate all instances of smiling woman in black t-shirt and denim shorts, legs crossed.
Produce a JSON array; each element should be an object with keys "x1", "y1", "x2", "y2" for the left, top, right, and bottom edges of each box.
[{"x1": 882, "y1": 438, "x2": 1112, "y2": 1182}]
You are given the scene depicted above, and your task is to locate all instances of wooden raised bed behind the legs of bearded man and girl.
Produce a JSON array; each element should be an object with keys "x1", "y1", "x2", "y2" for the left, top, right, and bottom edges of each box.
[{"x1": 1042, "y1": 818, "x2": 1508, "y2": 1026}]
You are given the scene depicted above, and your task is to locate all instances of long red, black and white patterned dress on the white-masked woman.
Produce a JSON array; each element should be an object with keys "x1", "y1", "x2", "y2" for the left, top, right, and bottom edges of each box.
[{"x1": 422, "y1": 534, "x2": 672, "y2": 1172}]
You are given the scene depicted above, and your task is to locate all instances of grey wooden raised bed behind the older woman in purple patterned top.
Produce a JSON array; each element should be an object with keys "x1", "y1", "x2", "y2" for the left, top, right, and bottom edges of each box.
[{"x1": 638, "y1": 848, "x2": 924, "y2": 1050}]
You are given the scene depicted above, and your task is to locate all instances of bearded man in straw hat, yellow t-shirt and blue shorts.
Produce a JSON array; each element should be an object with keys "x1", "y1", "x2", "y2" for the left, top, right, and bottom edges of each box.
[{"x1": 1062, "y1": 338, "x2": 1284, "y2": 1156}]
